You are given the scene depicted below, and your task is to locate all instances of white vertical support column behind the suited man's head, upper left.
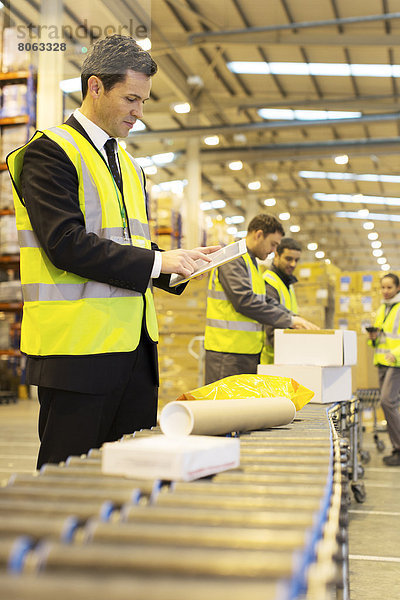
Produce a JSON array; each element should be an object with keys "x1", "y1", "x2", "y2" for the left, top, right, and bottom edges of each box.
[{"x1": 36, "y1": 0, "x2": 63, "y2": 129}]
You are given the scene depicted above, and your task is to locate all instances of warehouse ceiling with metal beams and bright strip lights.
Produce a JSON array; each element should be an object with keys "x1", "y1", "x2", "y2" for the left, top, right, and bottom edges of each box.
[{"x1": 7, "y1": 0, "x2": 400, "y2": 270}]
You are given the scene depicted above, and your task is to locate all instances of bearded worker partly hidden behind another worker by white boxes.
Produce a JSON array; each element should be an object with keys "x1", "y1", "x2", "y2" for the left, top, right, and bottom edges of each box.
[{"x1": 260, "y1": 237, "x2": 301, "y2": 365}]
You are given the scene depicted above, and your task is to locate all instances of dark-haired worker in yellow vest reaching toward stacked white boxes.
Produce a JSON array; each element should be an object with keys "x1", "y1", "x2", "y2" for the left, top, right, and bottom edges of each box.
[{"x1": 204, "y1": 214, "x2": 318, "y2": 384}]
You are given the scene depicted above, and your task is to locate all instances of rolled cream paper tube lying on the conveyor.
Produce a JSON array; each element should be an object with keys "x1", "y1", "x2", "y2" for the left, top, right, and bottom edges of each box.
[{"x1": 160, "y1": 397, "x2": 296, "y2": 436}]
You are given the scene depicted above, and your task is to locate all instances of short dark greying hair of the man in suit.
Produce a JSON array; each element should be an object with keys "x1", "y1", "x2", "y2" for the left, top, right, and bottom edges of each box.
[{"x1": 81, "y1": 34, "x2": 157, "y2": 98}]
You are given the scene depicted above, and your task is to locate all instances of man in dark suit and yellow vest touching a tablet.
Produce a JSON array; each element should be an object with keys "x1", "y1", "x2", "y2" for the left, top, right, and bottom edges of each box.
[{"x1": 9, "y1": 35, "x2": 217, "y2": 468}]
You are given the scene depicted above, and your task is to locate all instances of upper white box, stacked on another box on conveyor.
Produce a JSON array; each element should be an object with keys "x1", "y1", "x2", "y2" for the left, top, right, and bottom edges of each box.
[{"x1": 274, "y1": 329, "x2": 357, "y2": 367}]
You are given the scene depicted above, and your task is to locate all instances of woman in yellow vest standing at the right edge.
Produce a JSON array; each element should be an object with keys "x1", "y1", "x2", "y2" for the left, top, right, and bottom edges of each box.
[{"x1": 368, "y1": 273, "x2": 400, "y2": 467}]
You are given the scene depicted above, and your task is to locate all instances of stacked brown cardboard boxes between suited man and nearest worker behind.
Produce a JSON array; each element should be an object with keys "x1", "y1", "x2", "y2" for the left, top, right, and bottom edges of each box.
[{"x1": 154, "y1": 277, "x2": 208, "y2": 408}]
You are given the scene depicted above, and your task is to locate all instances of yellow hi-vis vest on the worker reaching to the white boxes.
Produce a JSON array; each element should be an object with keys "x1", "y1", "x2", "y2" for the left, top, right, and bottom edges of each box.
[{"x1": 204, "y1": 253, "x2": 265, "y2": 354}]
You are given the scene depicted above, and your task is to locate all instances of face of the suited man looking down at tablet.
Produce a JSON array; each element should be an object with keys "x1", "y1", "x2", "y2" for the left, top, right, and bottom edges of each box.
[{"x1": 95, "y1": 70, "x2": 151, "y2": 137}]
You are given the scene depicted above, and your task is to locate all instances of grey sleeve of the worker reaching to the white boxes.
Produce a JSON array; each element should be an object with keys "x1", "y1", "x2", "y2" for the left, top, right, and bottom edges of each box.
[{"x1": 218, "y1": 257, "x2": 292, "y2": 329}]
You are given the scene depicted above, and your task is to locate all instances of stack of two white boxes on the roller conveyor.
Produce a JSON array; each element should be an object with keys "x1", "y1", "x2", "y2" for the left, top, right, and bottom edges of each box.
[{"x1": 258, "y1": 329, "x2": 357, "y2": 404}]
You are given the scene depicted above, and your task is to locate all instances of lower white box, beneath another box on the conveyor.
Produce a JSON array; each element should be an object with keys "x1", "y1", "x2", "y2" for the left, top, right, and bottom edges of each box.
[{"x1": 257, "y1": 365, "x2": 352, "y2": 404}]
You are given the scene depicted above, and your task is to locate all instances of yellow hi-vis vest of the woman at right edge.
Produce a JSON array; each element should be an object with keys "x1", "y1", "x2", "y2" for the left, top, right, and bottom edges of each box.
[{"x1": 374, "y1": 303, "x2": 400, "y2": 367}]
